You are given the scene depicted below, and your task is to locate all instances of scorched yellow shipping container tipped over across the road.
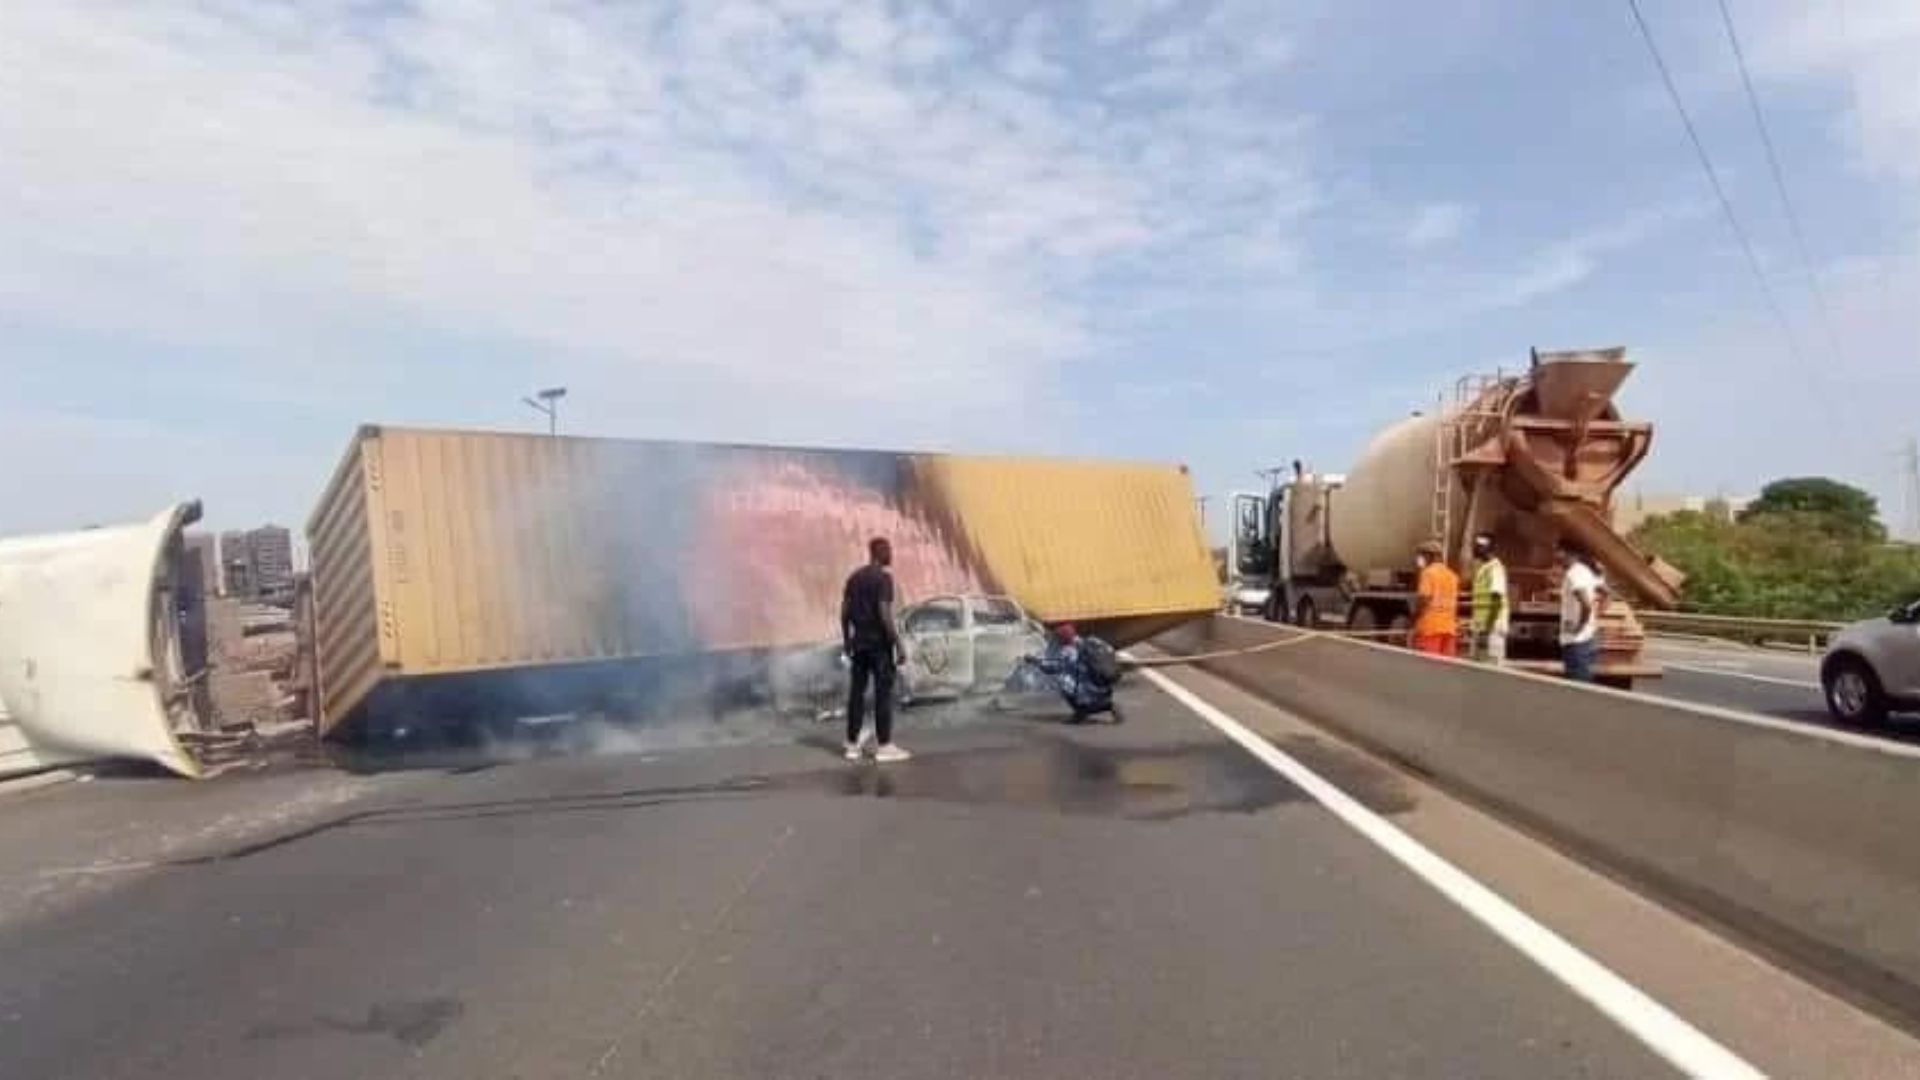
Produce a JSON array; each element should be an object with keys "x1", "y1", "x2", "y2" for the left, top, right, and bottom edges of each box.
[{"x1": 307, "y1": 427, "x2": 1219, "y2": 738}]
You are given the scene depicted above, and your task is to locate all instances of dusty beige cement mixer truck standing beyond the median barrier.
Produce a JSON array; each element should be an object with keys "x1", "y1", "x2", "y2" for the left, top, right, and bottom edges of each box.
[{"x1": 1229, "y1": 348, "x2": 1682, "y2": 686}]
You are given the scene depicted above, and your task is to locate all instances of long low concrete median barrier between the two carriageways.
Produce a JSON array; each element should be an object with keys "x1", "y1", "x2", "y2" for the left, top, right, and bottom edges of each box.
[{"x1": 1156, "y1": 617, "x2": 1920, "y2": 1026}]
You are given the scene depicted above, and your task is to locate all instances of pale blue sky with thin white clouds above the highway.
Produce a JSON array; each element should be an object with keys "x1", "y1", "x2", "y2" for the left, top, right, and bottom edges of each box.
[{"x1": 0, "y1": 0, "x2": 1920, "y2": 534}]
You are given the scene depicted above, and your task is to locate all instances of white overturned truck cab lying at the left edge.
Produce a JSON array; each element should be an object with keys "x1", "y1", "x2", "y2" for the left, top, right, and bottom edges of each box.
[{"x1": 0, "y1": 503, "x2": 205, "y2": 776}]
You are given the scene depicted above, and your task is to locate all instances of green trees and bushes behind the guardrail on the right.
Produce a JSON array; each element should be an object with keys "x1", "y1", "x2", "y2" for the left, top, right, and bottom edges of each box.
[{"x1": 1634, "y1": 477, "x2": 1920, "y2": 621}]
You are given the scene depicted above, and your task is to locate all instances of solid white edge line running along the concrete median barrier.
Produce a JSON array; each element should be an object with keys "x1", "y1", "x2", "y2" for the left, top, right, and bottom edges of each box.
[{"x1": 1144, "y1": 671, "x2": 1764, "y2": 1080}]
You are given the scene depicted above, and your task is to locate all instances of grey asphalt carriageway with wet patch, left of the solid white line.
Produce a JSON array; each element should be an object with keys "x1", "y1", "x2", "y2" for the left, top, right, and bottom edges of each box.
[{"x1": 0, "y1": 684, "x2": 1668, "y2": 1080}]
